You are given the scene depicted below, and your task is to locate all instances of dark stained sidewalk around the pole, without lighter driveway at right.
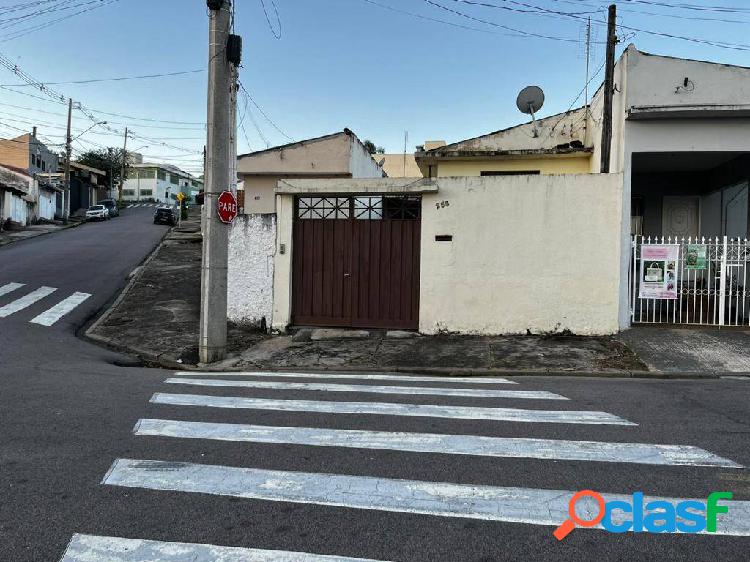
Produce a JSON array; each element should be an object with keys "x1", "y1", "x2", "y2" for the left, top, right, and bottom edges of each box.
[{"x1": 82, "y1": 216, "x2": 646, "y2": 373}]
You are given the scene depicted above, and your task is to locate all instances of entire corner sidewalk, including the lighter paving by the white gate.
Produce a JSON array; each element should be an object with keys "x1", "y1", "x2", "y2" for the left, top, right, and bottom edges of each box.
[{"x1": 86, "y1": 216, "x2": 750, "y2": 377}]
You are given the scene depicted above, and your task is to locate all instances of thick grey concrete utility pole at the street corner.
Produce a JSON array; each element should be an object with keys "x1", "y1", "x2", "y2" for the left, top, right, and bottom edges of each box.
[{"x1": 198, "y1": 0, "x2": 234, "y2": 363}]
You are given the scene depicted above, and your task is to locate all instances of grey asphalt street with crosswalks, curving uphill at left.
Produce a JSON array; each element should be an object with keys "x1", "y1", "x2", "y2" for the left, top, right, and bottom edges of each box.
[{"x1": 0, "y1": 209, "x2": 750, "y2": 562}]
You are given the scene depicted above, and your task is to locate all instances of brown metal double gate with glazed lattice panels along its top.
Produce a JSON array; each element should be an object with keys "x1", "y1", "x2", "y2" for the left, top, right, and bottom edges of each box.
[{"x1": 292, "y1": 195, "x2": 422, "y2": 329}]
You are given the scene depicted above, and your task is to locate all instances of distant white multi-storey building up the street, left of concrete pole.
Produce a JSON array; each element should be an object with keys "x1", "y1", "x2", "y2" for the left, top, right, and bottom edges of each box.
[{"x1": 122, "y1": 162, "x2": 203, "y2": 205}]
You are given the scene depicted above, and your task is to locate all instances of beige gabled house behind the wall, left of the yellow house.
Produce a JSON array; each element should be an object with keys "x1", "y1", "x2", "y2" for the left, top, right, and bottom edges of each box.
[{"x1": 237, "y1": 129, "x2": 384, "y2": 214}]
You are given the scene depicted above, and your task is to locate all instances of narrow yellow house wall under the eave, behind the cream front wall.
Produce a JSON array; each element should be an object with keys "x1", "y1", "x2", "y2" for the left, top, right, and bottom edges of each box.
[{"x1": 437, "y1": 154, "x2": 591, "y2": 177}]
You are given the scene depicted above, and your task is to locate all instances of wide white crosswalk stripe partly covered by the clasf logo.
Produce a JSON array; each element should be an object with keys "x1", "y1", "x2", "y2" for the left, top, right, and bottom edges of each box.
[{"x1": 102, "y1": 459, "x2": 750, "y2": 540}]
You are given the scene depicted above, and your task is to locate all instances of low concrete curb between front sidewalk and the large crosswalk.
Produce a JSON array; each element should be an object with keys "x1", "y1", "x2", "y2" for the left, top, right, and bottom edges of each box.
[{"x1": 175, "y1": 365, "x2": 750, "y2": 380}]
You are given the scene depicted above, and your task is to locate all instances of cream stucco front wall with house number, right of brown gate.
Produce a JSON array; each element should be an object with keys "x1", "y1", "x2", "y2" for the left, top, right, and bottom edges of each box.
[{"x1": 420, "y1": 174, "x2": 622, "y2": 334}]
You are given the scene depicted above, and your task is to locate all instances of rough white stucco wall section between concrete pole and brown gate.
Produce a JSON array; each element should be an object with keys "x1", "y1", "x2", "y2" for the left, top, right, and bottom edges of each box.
[{"x1": 227, "y1": 214, "x2": 276, "y2": 324}]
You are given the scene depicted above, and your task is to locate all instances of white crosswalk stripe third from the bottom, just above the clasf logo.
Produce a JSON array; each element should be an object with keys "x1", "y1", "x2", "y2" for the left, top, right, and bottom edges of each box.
[{"x1": 133, "y1": 419, "x2": 742, "y2": 468}]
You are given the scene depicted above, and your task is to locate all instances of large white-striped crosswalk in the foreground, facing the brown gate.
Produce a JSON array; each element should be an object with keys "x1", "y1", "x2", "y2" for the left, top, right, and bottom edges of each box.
[{"x1": 61, "y1": 371, "x2": 750, "y2": 562}]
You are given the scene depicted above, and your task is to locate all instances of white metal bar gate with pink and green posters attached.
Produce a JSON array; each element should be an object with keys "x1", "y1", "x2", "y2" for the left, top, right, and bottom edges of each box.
[{"x1": 630, "y1": 236, "x2": 750, "y2": 326}]
